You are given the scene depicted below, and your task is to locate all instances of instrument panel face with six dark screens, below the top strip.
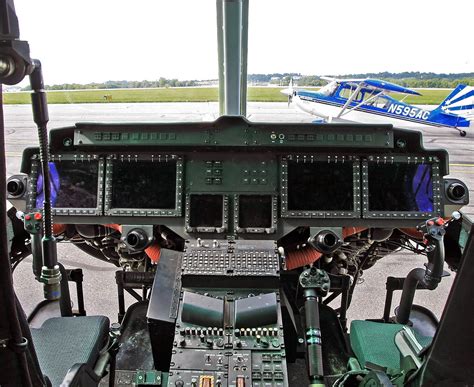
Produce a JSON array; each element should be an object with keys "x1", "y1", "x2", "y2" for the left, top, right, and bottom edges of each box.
[{"x1": 28, "y1": 152, "x2": 441, "y2": 227}]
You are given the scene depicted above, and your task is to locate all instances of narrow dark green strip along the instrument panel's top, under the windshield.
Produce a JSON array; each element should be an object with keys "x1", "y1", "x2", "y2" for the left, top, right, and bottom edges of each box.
[{"x1": 74, "y1": 121, "x2": 393, "y2": 148}]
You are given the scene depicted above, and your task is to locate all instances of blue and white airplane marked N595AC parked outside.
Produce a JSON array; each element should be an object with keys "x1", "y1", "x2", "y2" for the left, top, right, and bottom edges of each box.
[{"x1": 281, "y1": 77, "x2": 474, "y2": 137}]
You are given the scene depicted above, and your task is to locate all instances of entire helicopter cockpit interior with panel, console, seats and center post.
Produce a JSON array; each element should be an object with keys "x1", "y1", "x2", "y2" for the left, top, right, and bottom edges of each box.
[{"x1": 0, "y1": 0, "x2": 474, "y2": 387}]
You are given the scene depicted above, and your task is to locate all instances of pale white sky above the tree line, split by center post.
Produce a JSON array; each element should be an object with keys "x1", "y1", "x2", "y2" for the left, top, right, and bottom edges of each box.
[{"x1": 15, "y1": 0, "x2": 474, "y2": 84}]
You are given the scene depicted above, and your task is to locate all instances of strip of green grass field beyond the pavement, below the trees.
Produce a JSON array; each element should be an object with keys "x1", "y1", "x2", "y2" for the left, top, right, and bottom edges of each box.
[{"x1": 3, "y1": 87, "x2": 449, "y2": 105}]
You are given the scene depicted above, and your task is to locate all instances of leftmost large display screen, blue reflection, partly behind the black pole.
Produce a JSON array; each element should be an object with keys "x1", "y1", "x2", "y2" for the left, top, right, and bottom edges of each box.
[{"x1": 36, "y1": 160, "x2": 99, "y2": 208}]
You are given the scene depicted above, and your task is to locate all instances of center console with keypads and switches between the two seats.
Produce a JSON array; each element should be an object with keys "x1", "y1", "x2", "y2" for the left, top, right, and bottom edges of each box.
[{"x1": 167, "y1": 240, "x2": 288, "y2": 387}]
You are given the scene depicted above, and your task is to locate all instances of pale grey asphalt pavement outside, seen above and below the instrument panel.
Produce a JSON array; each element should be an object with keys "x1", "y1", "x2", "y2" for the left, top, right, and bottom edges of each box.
[{"x1": 4, "y1": 103, "x2": 474, "y2": 321}]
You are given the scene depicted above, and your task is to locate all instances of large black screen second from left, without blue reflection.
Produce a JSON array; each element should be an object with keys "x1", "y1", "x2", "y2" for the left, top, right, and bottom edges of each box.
[{"x1": 111, "y1": 161, "x2": 176, "y2": 209}]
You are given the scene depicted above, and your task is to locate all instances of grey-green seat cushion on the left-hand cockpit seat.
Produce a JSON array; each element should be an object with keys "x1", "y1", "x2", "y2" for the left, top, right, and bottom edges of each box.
[{"x1": 31, "y1": 316, "x2": 109, "y2": 387}]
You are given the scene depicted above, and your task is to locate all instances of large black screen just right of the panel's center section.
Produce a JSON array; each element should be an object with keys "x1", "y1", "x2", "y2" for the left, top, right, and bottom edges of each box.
[{"x1": 288, "y1": 161, "x2": 354, "y2": 211}]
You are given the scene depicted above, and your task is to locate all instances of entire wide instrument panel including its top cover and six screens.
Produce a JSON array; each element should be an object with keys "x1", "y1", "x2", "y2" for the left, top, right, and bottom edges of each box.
[{"x1": 10, "y1": 117, "x2": 467, "y2": 238}]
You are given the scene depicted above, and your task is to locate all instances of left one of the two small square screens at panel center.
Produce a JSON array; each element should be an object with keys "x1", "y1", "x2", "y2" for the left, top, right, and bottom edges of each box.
[{"x1": 189, "y1": 195, "x2": 224, "y2": 228}]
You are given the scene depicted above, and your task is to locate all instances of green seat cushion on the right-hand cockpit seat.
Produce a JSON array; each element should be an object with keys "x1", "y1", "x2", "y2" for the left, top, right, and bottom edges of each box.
[{"x1": 350, "y1": 320, "x2": 432, "y2": 369}]
